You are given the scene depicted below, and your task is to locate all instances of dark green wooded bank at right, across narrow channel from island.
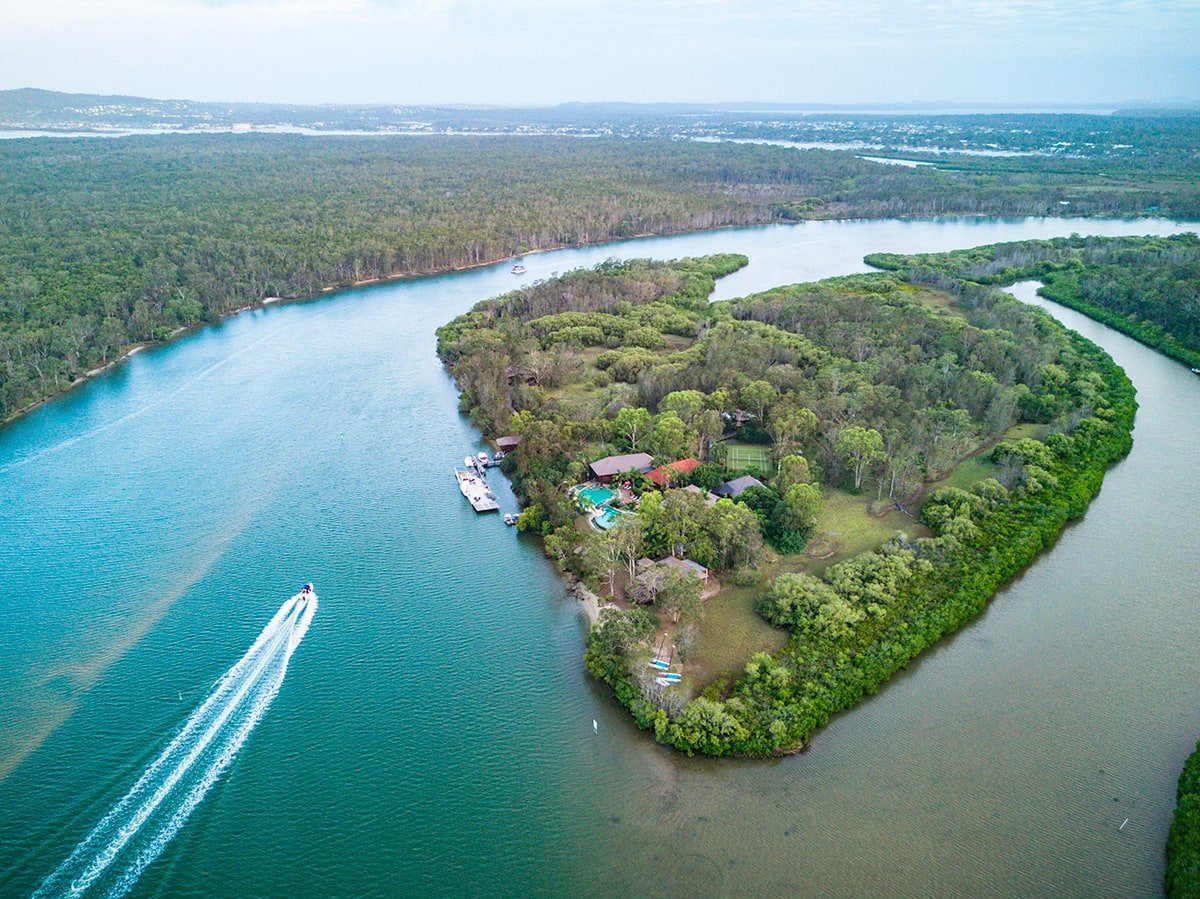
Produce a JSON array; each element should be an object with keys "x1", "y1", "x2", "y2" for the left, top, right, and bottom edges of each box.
[{"x1": 866, "y1": 233, "x2": 1200, "y2": 367}]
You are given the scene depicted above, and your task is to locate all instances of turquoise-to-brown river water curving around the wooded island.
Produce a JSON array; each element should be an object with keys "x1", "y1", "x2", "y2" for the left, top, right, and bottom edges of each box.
[{"x1": 0, "y1": 218, "x2": 1200, "y2": 897}]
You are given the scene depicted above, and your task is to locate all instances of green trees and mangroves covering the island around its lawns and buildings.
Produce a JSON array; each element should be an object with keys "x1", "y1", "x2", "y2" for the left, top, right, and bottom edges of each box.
[{"x1": 438, "y1": 257, "x2": 1135, "y2": 756}]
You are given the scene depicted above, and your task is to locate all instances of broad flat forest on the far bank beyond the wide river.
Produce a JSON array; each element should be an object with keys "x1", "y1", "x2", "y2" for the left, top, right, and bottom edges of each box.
[{"x1": 0, "y1": 134, "x2": 1200, "y2": 419}]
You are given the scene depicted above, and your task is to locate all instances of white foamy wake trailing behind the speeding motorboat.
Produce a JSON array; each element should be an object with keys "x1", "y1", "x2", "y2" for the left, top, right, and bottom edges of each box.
[{"x1": 34, "y1": 593, "x2": 317, "y2": 898}]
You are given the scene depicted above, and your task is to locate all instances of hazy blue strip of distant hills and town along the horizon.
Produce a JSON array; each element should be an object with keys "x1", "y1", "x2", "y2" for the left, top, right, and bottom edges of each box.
[{"x1": 0, "y1": 88, "x2": 1200, "y2": 175}]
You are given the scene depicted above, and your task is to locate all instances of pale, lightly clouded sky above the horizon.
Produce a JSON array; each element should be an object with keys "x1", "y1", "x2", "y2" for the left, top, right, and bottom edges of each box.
[{"x1": 0, "y1": 0, "x2": 1200, "y2": 107}]
